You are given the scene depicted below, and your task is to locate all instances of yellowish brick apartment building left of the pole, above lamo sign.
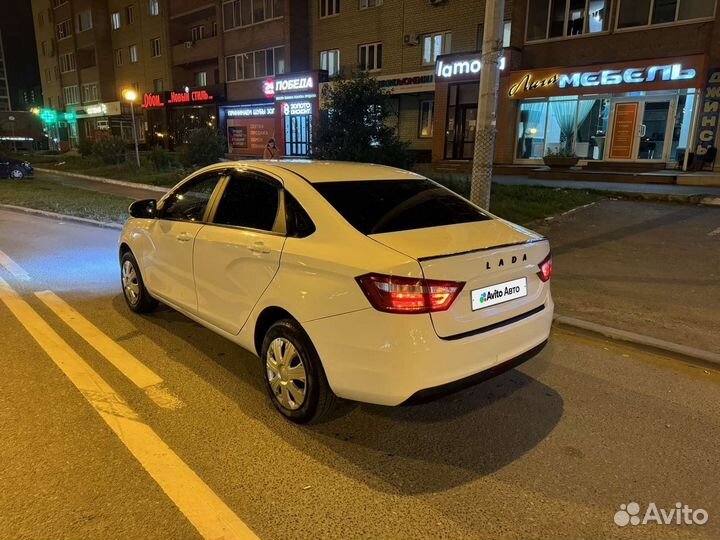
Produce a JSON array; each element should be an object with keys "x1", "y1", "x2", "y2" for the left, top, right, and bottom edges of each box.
[{"x1": 310, "y1": 0, "x2": 512, "y2": 161}]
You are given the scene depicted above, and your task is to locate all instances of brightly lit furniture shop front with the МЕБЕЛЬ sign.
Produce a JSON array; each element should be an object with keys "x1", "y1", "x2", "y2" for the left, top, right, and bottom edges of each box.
[{"x1": 498, "y1": 55, "x2": 705, "y2": 168}]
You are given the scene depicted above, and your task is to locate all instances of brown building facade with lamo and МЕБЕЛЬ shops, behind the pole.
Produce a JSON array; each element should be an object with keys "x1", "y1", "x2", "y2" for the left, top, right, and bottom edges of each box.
[{"x1": 433, "y1": 0, "x2": 720, "y2": 169}]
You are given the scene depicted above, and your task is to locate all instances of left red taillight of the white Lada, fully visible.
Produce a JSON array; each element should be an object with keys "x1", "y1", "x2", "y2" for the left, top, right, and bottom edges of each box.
[{"x1": 355, "y1": 274, "x2": 465, "y2": 313}]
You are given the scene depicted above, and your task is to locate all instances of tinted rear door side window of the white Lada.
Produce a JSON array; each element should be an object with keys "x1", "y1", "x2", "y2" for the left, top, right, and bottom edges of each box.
[{"x1": 213, "y1": 172, "x2": 280, "y2": 231}]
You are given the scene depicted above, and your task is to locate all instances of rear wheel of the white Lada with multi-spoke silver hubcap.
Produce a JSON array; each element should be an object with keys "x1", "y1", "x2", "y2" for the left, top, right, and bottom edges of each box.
[{"x1": 261, "y1": 319, "x2": 337, "y2": 424}]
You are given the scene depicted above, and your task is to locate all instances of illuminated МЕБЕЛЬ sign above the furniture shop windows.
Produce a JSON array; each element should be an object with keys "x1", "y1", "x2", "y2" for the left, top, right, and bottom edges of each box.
[{"x1": 507, "y1": 62, "x2": 697, "y2": 97}]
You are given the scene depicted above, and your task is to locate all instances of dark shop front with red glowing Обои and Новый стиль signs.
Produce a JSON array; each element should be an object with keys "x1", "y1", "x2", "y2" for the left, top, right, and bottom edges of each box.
[{"x1": 142, "y1": 85, "x2": 224, "y2": 149}]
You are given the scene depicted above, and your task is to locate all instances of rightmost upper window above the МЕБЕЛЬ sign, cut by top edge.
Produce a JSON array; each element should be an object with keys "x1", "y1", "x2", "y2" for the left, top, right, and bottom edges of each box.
[{"x1": 617, "y1": 0, "x2": 715, "y2": 28}]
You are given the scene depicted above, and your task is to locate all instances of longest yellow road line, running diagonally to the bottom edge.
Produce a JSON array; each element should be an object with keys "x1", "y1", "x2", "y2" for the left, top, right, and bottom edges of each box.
[{"x1": 0, "y1": 278, "x2": 258, "y2": 540}]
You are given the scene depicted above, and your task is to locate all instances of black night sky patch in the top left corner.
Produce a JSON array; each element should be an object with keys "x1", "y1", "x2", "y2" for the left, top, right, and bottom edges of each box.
[{"x1": 0, "y1": 0, "x2": 40, "y2": 109}]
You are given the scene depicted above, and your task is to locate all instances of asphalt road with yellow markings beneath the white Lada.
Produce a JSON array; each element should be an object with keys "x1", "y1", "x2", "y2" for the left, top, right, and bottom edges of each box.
[{"x1": 0, "y1": 211, "x2": 720, "y2": 540}]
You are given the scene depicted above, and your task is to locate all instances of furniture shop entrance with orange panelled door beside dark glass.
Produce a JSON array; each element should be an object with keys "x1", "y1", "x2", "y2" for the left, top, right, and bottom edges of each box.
[{"x1": 606, "y1": 98, "x2": 675, "y2": 162}]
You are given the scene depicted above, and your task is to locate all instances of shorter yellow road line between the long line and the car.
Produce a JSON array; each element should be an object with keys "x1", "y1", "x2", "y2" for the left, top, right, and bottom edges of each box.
[{"x1": 35, "y1": 291, "x2": 183, "y2": 409}]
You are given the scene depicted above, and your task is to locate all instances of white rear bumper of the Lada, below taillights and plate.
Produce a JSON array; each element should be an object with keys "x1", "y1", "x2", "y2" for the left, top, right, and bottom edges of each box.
[{"x1": 303, "y1": 294, "x2": 554, "y2": 405}]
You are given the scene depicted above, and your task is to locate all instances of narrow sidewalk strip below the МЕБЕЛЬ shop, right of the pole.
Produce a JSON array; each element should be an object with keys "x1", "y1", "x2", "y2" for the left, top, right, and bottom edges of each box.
[{"x1": 493, "y1": 175, "x2": 720, "y2": 198}]
